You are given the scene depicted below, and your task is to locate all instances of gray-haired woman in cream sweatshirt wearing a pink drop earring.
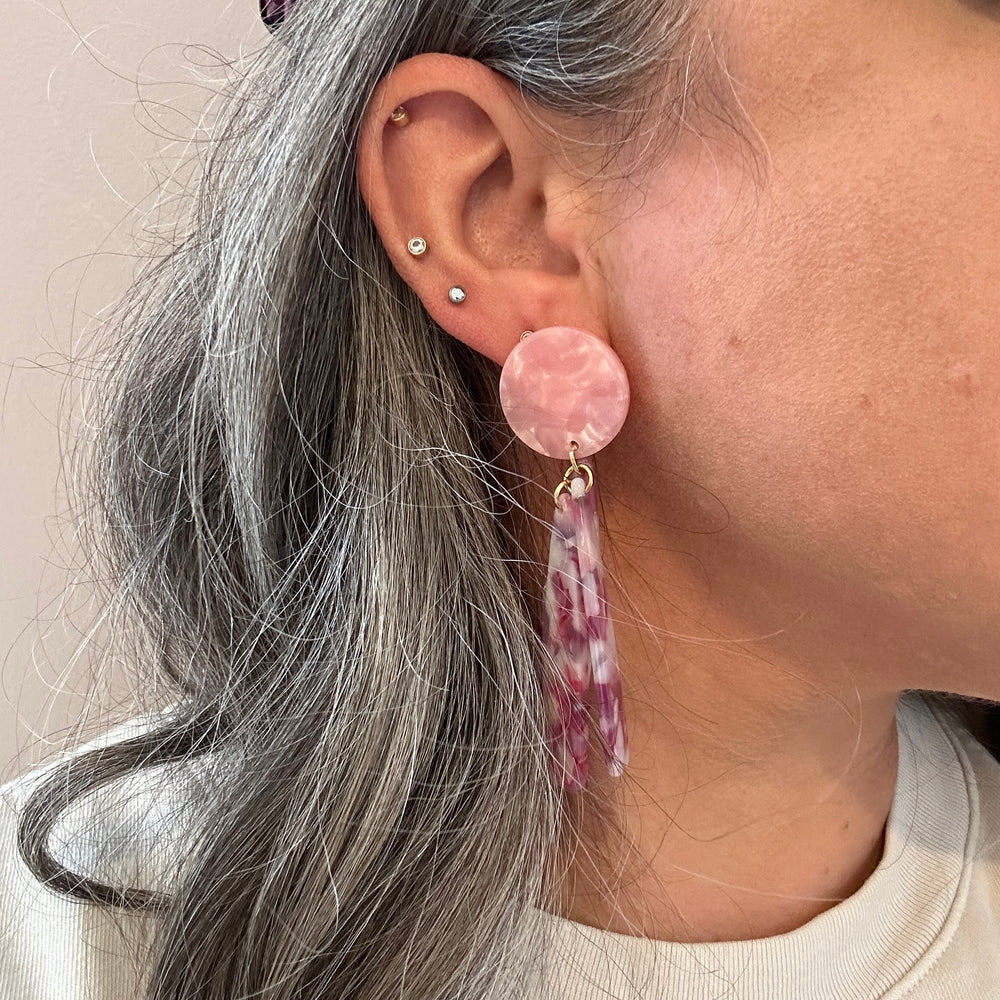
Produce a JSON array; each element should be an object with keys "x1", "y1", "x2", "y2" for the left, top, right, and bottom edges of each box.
[{"x1": 0, "y1": 0, "x2": 1000, "y2": 1000}]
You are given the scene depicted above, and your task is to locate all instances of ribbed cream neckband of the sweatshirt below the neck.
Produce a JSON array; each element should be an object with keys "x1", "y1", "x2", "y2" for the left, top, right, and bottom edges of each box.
[{"x1": 539, "y1": 692, "x2": 979, "y2": 1000}]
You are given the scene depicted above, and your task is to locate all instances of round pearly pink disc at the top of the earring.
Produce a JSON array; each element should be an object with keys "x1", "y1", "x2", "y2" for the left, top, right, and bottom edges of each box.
[{"x1": 500, "y1": 326, "x2": 629, "y2": 458}]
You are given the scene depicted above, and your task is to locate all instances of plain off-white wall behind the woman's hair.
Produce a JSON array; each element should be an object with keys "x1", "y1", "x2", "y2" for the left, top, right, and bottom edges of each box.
[{"x1": 0, "y1": 0, "x2": 269, "y2": 780}]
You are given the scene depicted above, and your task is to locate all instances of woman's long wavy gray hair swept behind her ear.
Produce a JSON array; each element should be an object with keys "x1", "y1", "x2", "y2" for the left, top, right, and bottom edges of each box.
[{"x1": 20, "y1": 0, "x2": 694, "y2": 1000}]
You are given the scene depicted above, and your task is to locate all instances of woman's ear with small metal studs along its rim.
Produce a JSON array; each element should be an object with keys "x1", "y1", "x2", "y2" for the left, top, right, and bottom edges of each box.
[{"x1": 358, "y1": 53, "x2": 606, "y2": 364}]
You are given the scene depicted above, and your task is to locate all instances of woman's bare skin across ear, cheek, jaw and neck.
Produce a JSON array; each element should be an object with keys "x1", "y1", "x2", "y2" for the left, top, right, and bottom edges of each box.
[{"x1": 358, "y1": 0, "x2": 1000, "y2": 941}]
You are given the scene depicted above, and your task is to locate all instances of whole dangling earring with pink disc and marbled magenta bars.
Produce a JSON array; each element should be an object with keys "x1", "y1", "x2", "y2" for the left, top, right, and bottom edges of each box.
[{"x1": 500, "y1": 326, "x2": 629, "y2": 791}]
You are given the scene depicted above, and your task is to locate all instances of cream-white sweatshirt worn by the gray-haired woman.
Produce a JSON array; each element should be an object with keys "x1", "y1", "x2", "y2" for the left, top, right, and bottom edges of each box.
[{"x1": 0, "y1": 692, "x2": 1000, "y2": 1000}]
